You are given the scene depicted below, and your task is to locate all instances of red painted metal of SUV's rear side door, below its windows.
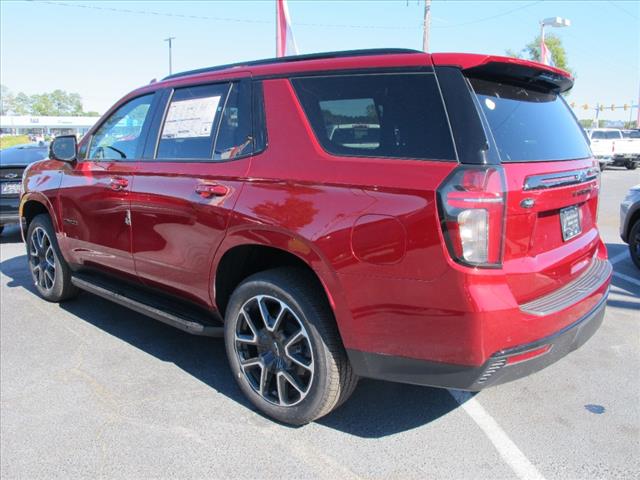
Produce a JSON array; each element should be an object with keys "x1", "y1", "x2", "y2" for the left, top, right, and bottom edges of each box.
[{"x1": 131, "y1": 158, "x2": 251, "y2": 306}]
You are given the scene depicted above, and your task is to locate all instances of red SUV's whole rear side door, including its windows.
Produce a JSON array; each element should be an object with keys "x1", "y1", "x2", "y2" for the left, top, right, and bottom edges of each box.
[{"x1": 131, "y1": 78, "x2": 254, "y2": 304}]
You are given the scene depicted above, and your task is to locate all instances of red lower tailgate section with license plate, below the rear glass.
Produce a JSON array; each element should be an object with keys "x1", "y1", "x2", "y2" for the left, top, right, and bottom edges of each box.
[{"x1": 504, "y1": 160, "x2": 599, "y2": 303}]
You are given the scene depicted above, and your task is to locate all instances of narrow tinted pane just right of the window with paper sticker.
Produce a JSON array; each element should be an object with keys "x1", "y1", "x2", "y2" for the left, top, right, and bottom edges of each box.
[{"x1": 213, "y1": 81, "x2": 254, "y2": 160}]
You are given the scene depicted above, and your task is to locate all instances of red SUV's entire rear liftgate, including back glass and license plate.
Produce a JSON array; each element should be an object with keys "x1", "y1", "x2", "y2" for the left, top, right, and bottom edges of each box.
[{"x1": 469, "y1": 75, "x2": 600, "y2": 303}]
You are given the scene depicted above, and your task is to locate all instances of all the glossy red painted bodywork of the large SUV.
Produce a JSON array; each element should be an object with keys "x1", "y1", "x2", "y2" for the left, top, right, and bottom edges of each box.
[{"x1": 23, "y1": 53, "x2": 608, "y2": 378}]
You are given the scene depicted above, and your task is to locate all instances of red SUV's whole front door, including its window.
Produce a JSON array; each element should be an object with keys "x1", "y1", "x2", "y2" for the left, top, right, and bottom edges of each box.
[{"x1": 59, "y1": 94, "x2": 154, "y2": 276}]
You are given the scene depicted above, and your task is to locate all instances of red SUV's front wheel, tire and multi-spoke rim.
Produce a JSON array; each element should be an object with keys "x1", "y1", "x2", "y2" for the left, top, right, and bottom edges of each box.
[{"x1": 26, "y1": 214, "x2": 79, "y2": 302}]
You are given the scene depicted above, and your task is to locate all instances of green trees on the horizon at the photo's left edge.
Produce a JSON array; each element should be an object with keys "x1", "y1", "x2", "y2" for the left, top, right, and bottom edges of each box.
[{"x1": 1, "y1": 85, "x2": 99, "y2": 117}]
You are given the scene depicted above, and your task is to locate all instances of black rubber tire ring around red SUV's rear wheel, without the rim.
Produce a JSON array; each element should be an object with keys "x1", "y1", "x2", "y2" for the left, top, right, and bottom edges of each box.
[{"x1": 224, "y1": 279, "x2": 333, "y2": 425}]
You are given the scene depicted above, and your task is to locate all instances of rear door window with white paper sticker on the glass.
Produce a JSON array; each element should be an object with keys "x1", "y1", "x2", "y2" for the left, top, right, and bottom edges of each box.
[{"x1": 156, "y1": 84, "x2": 229, "y2": 160}]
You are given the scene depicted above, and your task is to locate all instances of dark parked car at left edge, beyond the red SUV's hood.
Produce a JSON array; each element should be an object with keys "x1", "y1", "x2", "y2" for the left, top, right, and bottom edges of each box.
[{"x1": 0, "y1": 143, "x2": 49, "y2": 233}]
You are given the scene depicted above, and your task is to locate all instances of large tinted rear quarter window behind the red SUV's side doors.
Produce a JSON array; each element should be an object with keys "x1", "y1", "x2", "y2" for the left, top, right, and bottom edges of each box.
[{"x1": 292, "y1": 73, "x2": 456, "y2": 160}]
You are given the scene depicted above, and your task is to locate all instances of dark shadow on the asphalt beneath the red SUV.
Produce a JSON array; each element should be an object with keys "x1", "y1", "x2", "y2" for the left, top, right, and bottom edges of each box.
[{"x1": 0, "y1": 253, "x2": 458, "y2": 438}]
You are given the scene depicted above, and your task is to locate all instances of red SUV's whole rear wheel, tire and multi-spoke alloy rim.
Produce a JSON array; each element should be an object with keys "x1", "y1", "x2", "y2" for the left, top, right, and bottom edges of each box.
[{"x1": 225, "y1": 268, "x2": 358, "y2": 425}]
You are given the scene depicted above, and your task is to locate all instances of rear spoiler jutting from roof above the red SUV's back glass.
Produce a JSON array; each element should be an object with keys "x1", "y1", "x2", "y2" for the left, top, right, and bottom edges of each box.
[{"x1": 431, "y1": 53, "x2": 573, "y2": 93}]
